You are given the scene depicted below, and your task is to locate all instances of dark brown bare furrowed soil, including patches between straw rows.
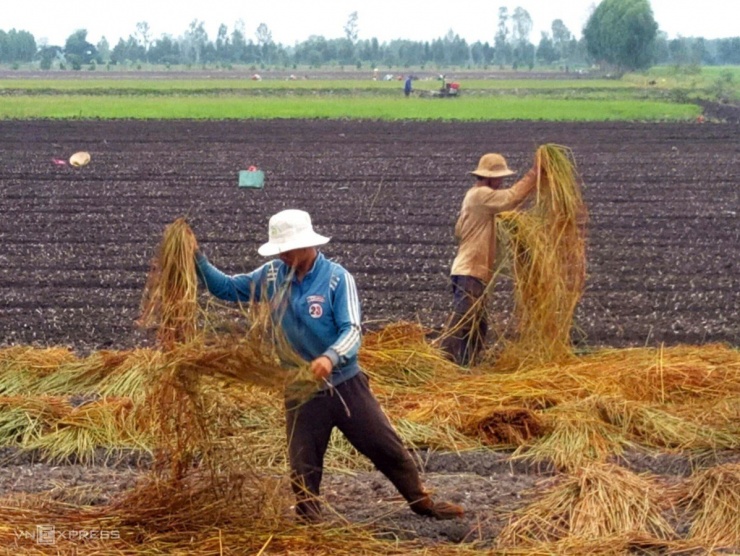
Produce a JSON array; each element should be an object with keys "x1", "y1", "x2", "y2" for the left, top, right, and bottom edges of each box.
[{"x1": 0, "y1": 119, "x2": 740, "y2": 546}]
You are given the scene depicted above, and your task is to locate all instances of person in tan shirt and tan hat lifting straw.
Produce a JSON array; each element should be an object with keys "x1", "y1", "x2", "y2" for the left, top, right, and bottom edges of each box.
[{"x1": 442, "y1": 153, "x2": 537, "y2": 365}]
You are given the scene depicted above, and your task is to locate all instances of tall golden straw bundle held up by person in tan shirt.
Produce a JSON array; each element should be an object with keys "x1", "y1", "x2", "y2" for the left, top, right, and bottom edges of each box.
[{"x1": 497, "y1": 144, "x2": 587, "y2": 369}]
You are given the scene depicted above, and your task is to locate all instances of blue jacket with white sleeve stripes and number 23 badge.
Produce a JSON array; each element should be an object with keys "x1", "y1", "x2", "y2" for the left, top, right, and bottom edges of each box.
[{"x1": 196, "y1": 253, "x2": 362, "y2": 386}]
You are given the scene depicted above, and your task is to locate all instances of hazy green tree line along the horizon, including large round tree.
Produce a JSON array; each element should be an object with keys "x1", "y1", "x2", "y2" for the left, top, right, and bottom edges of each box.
[{"x1": 0, "y1": 0, "x2": 740, "y2": 73}]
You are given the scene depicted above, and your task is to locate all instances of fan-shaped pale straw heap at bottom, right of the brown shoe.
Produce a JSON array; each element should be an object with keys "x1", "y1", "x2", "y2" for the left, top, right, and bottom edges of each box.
[{"x1": 498, "y1": 463, "x2": 675, "y2": 547}]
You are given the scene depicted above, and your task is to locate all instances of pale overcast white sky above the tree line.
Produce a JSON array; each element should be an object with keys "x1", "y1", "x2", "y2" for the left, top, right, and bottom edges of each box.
[{"x1": 0, "y1": 0, "x2": 740, "y2": 46}]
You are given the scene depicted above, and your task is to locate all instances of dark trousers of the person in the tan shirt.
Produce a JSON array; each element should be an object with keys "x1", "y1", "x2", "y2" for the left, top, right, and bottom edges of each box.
[{"x1": 442, "y1": 276, "x2": 488, "y2": 365}]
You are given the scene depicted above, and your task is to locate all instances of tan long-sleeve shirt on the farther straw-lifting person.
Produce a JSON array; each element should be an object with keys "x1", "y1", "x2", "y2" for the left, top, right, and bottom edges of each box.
[{"x1": 450, "y1": 169, "x2": 537, "y2": 283}]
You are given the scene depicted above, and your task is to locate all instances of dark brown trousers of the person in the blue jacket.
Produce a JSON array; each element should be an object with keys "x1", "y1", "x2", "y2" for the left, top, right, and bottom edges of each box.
[{"x1": 286, "y1": 373, "x2": 426, "y2": 518}]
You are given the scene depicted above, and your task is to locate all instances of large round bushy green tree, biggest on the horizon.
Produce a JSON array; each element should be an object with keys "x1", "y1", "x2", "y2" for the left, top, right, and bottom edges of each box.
[{"x1": 583, "y1": 0, "x2": 658, "y2": 73}]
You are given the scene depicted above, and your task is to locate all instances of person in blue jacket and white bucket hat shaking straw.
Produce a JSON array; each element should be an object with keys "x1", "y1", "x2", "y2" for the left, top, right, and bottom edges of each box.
[{"x1": 191, "y1": 209, "x2": 463, "y2": 522}]
